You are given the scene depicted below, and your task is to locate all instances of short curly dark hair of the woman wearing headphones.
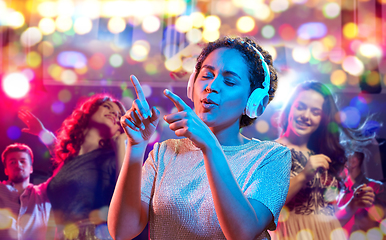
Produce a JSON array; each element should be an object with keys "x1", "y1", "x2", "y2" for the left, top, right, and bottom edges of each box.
[{"x1": 194, "y1": 36, "x2": 277, "y2": 128}]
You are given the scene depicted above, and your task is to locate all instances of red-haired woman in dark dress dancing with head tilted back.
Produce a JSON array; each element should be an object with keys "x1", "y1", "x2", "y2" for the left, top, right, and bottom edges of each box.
[{"x1": 19, "y1": 95, "x2": 126, "y2": 240}]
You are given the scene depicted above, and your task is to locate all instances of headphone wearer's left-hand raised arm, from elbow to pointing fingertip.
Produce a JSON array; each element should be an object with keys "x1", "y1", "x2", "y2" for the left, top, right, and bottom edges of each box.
[{"x1": 108, "y1": 76, "x2": 159, "y2": 239}]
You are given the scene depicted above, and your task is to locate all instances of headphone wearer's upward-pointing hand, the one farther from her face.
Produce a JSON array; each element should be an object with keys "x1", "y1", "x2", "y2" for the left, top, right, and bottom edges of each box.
[{"x1": 121, "y1": 75, "x2": 160, "y2": 146}]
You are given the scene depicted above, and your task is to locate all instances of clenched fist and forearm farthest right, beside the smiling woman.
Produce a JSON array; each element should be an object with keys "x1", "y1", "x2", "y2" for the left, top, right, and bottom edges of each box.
[{"x1": 335, "y1": 184, "x2": 375, "y2": 226}]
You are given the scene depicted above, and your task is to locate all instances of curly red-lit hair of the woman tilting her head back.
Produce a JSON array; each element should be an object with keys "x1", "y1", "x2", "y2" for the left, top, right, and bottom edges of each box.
[{"x1": 55, "y1": 94, "x2": 126, "y2": 165}]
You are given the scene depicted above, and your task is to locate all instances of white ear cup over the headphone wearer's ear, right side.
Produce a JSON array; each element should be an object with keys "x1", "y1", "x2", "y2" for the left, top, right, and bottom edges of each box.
[{"x1": 244, "y1": 88, "x2": 269, "y2": 118}]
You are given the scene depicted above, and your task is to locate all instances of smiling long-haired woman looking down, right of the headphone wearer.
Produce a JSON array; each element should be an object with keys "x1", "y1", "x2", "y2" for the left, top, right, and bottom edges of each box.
[{"x1": 276, "y1": 81, "x2": 374, "y2": 240}]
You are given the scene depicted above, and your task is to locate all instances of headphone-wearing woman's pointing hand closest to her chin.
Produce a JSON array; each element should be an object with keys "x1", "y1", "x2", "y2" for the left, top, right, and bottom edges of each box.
[{"x1": 164, "y1": 89, "x2": 215, "y2": 150}]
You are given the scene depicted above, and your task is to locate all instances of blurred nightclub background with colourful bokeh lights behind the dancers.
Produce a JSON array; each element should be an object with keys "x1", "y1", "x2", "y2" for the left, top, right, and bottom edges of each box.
[{"x1": 0, "y1": 0, "x2": 386, "y2": 238}]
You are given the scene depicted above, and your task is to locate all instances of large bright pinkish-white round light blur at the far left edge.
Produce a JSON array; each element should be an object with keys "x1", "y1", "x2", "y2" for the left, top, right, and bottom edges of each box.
[{"x1": 2, "y1": 73, "x2": 30, "y2": 99}]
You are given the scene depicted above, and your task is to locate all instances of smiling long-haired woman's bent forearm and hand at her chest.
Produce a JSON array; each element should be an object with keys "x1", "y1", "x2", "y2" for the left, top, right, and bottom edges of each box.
[{"x1": 285, "y1": 154, "x2": 331, "y2": 204}]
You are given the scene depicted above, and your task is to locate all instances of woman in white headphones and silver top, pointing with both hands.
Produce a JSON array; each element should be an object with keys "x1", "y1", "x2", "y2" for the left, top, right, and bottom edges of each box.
[{"x1": 108, "y1": 37, "x2": 290, "y2": 239}]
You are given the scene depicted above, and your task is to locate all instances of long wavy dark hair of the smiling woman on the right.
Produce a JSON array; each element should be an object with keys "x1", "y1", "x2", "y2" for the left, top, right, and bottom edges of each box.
[{"x1": 279, "y1": 81, "x2": 367, "y2": 187}]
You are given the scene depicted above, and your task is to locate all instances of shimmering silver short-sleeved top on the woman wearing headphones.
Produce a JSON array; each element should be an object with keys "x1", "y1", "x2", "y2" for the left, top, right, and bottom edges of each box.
[{"x1": 141, "y1": 138, "x2": 291, "y2": 239}]
